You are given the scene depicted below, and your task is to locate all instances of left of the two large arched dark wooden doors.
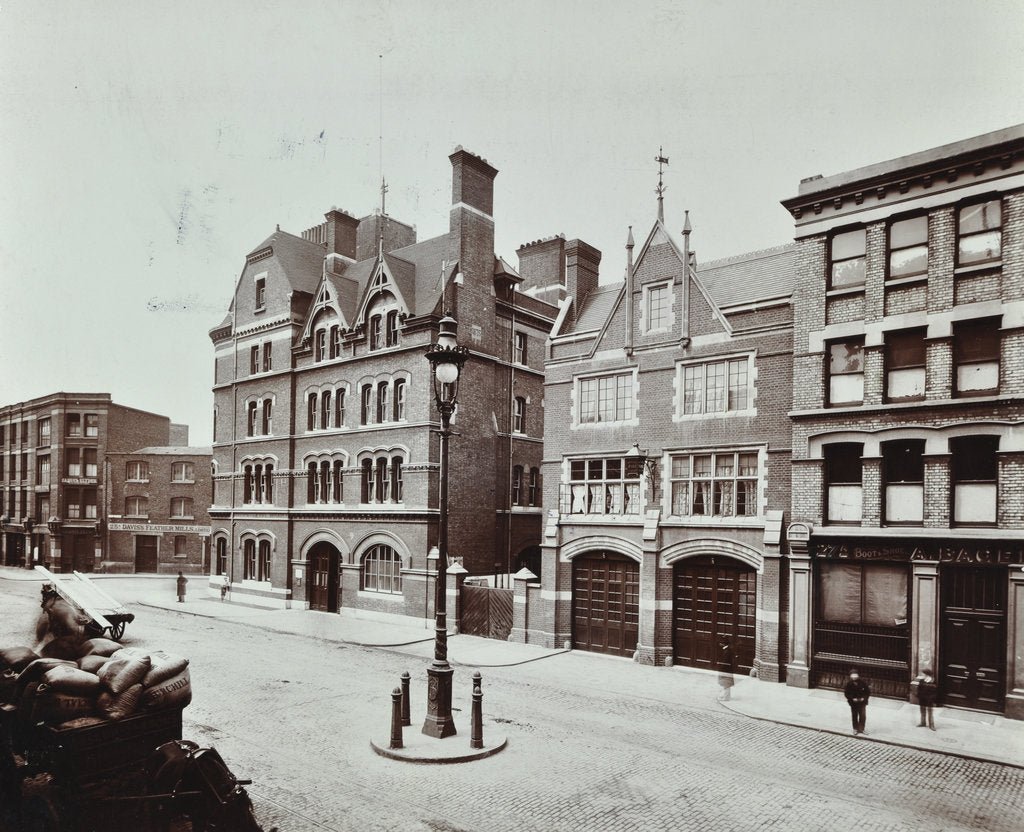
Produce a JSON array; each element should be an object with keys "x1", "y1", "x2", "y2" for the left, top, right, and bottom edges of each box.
[{"x1": 572, "y1": 551, "x2": 640, "y2": 656}]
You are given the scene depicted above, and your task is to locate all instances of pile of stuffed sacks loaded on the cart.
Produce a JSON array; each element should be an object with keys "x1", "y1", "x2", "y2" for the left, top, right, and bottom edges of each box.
[{"x1": 0, "y1": 638, "x2": 191, "y2": 729}]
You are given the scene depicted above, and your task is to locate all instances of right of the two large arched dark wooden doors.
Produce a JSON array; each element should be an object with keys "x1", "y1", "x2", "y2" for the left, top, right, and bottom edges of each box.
[{"x1": 673, "y1": 555, "x2": 757, "y2": 673}]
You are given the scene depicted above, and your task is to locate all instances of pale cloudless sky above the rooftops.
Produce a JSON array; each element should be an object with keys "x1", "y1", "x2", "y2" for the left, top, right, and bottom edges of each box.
[{"x1": 0, "y1": 0, "x2": 1024, "y2": 445}]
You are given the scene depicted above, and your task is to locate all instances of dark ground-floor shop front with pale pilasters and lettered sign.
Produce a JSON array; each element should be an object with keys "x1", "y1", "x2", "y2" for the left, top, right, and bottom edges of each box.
[{"x1": 791, "y1": 524, "x2": 1024, "y2": 718}]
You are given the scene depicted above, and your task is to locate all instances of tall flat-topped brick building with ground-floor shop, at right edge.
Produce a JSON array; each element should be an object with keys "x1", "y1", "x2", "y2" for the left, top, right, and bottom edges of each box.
[{"x1": 782, "y1": 125, "x2": 1024, "y2": 718}]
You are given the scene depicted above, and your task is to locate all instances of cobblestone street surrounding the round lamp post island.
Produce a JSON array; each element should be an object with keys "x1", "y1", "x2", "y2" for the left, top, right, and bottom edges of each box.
[{"x1": 0, "y1": 582, "x2": 1024, "y2": 832}]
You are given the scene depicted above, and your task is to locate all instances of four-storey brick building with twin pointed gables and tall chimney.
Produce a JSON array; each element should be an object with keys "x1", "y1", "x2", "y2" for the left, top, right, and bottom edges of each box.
[{"x1": 210, "y1": 148, "x2": 563, "y2": 618}]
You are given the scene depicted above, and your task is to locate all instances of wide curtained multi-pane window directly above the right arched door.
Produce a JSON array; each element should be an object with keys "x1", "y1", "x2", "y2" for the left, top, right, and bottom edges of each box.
[{"x1": 672, "y1": 451, "x2": 758, "y2": 517}]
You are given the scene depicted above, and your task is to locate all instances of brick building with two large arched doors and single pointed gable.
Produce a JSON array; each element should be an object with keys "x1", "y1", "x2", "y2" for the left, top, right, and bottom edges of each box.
[{"x1": 512, "y1": 198, "x2": 794, "y2": 680}]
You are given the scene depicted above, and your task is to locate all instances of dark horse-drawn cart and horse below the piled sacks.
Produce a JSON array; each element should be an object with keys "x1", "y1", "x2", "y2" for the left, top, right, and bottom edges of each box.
[{"x1": 0, "y1": 704, "x2": 270, "y2": 832}]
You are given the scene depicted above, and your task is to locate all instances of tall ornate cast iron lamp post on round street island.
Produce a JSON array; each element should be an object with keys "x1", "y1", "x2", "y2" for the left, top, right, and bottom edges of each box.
[{"x1": 423, "y1": 316, "x2": 469, "y2": 740}]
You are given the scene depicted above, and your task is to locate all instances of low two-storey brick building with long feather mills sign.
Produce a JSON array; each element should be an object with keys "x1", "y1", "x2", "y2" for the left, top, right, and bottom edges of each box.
[{"x1": 102, "y1": 446, "x2": 213, "y2": 574}]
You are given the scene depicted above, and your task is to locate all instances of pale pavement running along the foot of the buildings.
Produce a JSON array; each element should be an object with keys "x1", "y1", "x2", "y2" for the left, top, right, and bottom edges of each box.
[{"x1": 8, "y1": 568, "x2": 1024, "y2": 768}]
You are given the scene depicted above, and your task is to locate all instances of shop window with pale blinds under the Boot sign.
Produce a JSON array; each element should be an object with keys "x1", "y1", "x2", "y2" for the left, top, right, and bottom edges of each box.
[{"x1": 819, "y1": 560, "x2": 907, "y2": 627}]
